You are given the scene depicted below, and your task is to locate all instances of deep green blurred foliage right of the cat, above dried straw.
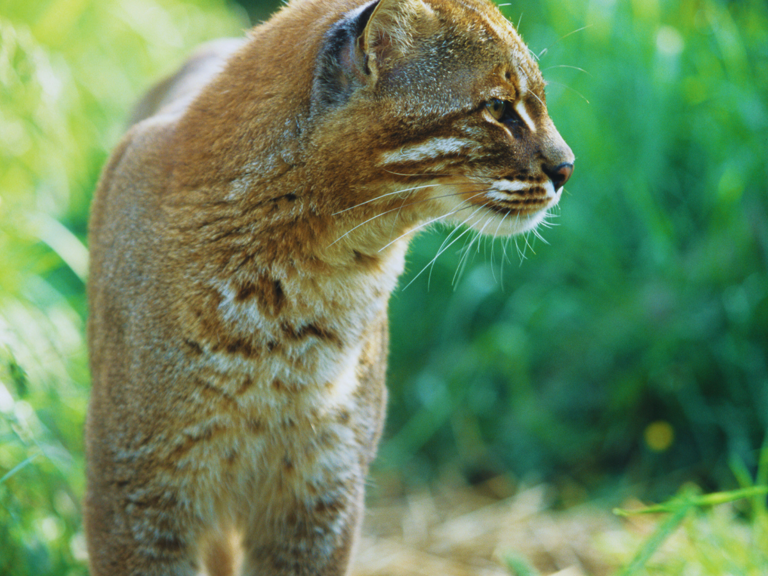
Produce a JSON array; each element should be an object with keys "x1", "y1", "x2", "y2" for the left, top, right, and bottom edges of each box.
[{"x1": 379, "y1": 0, "x2": 768, "y2": 500}]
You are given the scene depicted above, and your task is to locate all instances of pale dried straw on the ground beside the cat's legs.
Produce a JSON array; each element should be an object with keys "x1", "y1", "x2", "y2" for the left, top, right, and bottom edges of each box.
[{"x1": 352, "y1": 485, "x2": 621, "y2": 576}]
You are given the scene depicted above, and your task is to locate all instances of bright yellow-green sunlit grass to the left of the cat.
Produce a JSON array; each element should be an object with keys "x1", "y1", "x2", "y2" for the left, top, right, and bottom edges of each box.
[{"x1": 0, "y1": 0, "x2": 244, "y2": 576}]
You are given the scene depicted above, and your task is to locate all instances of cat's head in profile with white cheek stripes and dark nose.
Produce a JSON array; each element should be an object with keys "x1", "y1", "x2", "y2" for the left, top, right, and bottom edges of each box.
[{"x1": 311, "y1": 0, "x2": 574, "y2": 244}]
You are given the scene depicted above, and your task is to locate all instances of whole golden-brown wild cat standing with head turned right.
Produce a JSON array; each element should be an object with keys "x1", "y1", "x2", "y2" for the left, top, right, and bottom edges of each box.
[{"x1": 85, "y1": 0, "x2": 574, "y2": 576}]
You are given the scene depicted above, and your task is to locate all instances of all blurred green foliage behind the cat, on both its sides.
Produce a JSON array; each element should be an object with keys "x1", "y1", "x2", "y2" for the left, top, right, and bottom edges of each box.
[{"x1": 0, "y1": 0, "x2": 768, "y2": 575}]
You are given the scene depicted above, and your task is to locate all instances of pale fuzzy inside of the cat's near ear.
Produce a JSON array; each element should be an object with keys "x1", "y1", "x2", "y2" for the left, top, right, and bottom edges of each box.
[{"x1": 358, "y1": 0, "x2": 437, "y2": 79}]
